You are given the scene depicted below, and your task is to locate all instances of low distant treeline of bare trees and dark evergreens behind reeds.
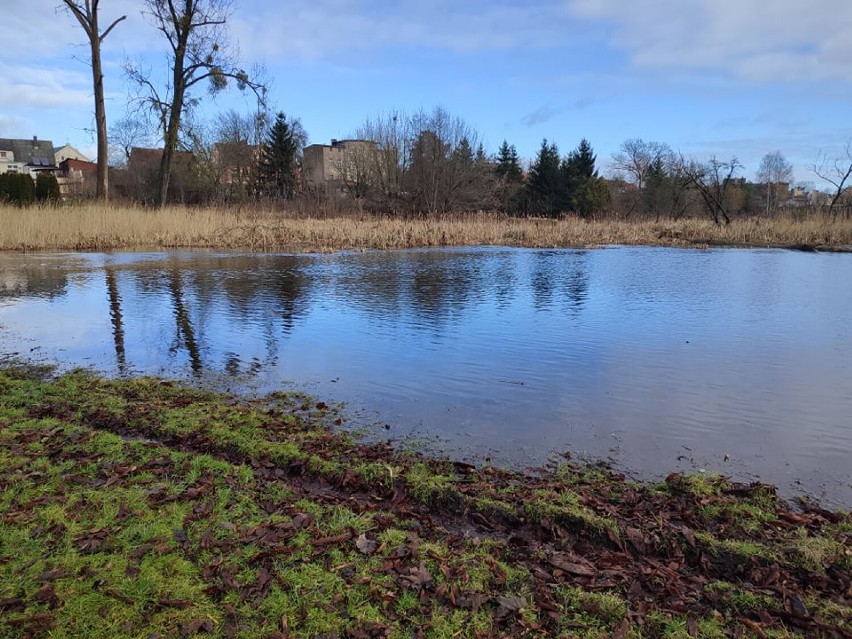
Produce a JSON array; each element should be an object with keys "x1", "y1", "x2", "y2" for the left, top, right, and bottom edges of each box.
[{"x1": 101, "y1": 108, "x2": 852, "y2": 224}]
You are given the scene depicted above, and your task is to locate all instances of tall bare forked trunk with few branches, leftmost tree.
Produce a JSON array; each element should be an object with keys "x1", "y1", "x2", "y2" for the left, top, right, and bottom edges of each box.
[{"x1": 62, "y1": 0, "x2": 127, "y2": 200}]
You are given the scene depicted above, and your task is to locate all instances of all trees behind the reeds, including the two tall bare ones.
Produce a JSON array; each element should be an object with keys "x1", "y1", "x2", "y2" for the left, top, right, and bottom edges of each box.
[{"x1": 63, "y1": 0, "x2": 852, "y2": 223}]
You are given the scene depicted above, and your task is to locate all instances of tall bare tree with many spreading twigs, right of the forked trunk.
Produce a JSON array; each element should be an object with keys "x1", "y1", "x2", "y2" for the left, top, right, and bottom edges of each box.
[{"x1": 125, "y1": 0, "x2": 265, "y2": 206}]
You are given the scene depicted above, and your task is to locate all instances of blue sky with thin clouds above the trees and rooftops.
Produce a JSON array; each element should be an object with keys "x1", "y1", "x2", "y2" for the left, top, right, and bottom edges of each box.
[{"x1": 0, "y1": 0, "x2": 852, "y2": 187}]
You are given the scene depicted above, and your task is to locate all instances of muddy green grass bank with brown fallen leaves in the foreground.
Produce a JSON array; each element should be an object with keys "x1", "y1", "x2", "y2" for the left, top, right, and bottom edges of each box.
[{"x1": 0, "y1": 367, "x2": 852, "y2": 639}]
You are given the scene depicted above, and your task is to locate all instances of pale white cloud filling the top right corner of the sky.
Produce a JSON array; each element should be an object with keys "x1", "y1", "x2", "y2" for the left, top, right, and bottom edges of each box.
[{"x1": 567, "y1": 0, "x2": 852, "y2": 82}]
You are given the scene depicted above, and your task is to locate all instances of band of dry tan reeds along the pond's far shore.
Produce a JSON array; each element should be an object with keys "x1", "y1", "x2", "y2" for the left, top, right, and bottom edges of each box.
[{"x1": 0, "y1": 204, "x2": 852, "y2": 251}]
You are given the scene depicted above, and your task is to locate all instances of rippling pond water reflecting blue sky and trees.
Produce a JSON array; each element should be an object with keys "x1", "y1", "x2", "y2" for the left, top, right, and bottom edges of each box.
[{"x1": 0, "y1": 247, "x2": 852, "y2": 508}]
